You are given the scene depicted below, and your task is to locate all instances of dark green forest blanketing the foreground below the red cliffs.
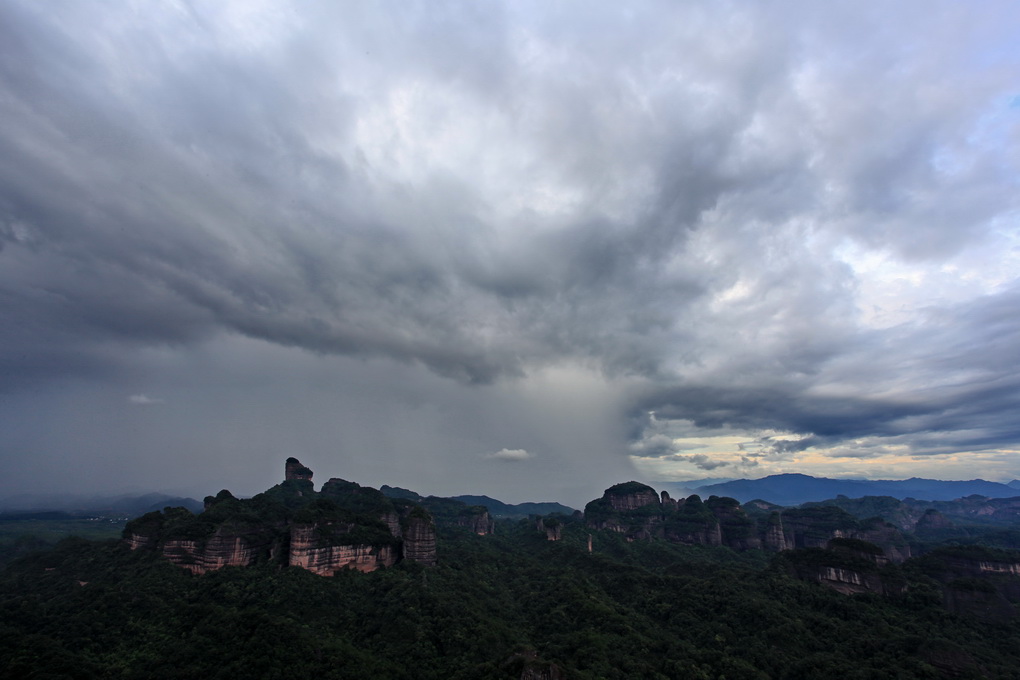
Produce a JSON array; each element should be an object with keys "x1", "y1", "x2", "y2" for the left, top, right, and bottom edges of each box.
[{"x1": 0, "y1": 513, "x2": 1020, "y2": 680}]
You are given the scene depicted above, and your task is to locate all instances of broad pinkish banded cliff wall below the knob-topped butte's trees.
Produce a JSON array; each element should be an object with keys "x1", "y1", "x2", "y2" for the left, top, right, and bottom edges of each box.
[{"x1": 288, "y1": 524, "x2": 398, "y2": 576}]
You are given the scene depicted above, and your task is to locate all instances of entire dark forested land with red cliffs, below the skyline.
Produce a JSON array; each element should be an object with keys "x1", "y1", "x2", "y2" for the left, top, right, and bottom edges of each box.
[{"x1": 0, "y1": 458, "x2": 1020, "y2": 680}]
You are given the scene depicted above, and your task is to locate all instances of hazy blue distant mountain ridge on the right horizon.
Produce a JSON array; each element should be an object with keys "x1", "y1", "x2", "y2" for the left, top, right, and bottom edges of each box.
[{"x1": 693, "y1": 474, "x2": 1020, "y2": 506}]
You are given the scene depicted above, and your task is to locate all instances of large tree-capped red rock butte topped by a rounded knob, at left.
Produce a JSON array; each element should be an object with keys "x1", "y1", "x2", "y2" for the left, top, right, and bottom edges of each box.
[{"x1": 123, "y1": 458, "x2": 434, "y2": 576}]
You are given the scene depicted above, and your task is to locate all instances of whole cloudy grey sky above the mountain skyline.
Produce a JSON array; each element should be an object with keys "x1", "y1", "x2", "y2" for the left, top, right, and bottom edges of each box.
[{"x1": 0, "y1": 0, "x2": 1020, "y2": 507}]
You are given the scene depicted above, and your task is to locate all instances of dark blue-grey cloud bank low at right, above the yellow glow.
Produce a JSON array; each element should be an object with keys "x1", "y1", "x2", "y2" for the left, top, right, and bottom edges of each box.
[{"x1": 631, "y1": 279, "x2": 1020, "y2": 457}]
